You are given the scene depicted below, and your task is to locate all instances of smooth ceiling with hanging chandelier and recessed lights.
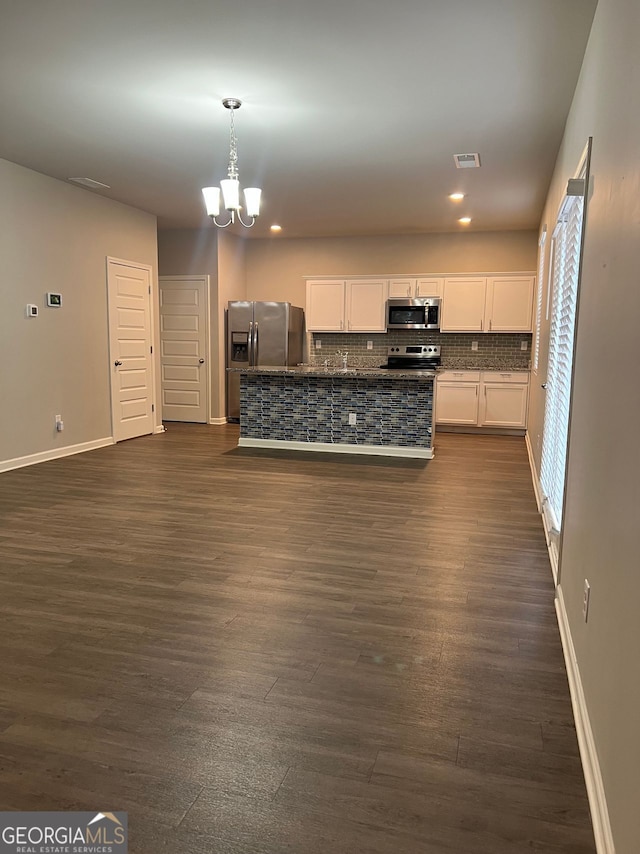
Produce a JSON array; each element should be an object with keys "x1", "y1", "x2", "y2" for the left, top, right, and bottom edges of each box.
[{"x1": 0, "y1": 0, "x2": 596, "y2": 237}]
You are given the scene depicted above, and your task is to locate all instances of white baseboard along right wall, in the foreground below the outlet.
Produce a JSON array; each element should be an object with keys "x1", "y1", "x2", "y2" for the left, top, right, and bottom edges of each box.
[{"x1": 556, "y1": 586, "x2": 615, "y2": 854}]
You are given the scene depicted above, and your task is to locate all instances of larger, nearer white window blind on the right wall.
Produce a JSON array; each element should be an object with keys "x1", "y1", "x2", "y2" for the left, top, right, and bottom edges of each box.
[{"x1": 540, "y1": 196, "x2": 584, "y2": 531}]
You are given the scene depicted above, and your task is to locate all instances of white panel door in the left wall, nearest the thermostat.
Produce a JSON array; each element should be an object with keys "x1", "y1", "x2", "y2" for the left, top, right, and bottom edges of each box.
[{"x1": 107, "y1": 259, "x2": 153, "y2": 442}]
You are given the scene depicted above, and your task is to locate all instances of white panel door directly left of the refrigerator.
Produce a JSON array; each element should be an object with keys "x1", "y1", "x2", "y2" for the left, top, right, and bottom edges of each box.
[{"x1": 159, "y1": 276, "x2": 208, "y2": 424}]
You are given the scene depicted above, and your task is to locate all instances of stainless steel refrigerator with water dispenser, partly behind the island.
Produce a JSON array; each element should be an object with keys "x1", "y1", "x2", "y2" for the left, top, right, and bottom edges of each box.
[{"x1": 226, "y1": 301, "x2": 304, "y2": 421}]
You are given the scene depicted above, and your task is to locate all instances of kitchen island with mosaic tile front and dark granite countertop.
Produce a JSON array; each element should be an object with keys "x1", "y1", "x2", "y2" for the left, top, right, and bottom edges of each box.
[{"x1": 229, "y1": 366, "x2": 435, "y2": 459}]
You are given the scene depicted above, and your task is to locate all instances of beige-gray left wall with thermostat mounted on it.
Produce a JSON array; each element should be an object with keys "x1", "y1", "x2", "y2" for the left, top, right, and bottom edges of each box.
[{"x1": 0, "y1": 160, "x2": 159, "y2": 463}]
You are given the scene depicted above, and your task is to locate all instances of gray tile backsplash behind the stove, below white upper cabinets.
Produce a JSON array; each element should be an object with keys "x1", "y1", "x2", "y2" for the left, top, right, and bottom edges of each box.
[{"x1": 309, "y1": 329, "x2": 532, "y2": 370}]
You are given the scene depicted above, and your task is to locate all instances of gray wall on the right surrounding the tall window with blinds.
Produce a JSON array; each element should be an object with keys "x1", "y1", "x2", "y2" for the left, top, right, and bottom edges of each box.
[{"x1": 529, "y1": 0, "x2": 640, "y2": 854}]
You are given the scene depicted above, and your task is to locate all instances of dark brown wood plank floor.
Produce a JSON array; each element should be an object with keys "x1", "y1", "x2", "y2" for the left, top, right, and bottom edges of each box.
[{"x1": 0, "y1": 424, "x2": 595, "y2": 854}]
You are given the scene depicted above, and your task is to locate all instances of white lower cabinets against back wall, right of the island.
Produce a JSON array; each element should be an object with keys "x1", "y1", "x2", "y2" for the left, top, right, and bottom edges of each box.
[{"x1": 436, "y1": 371, "x2": 529, "y2": 428}]
